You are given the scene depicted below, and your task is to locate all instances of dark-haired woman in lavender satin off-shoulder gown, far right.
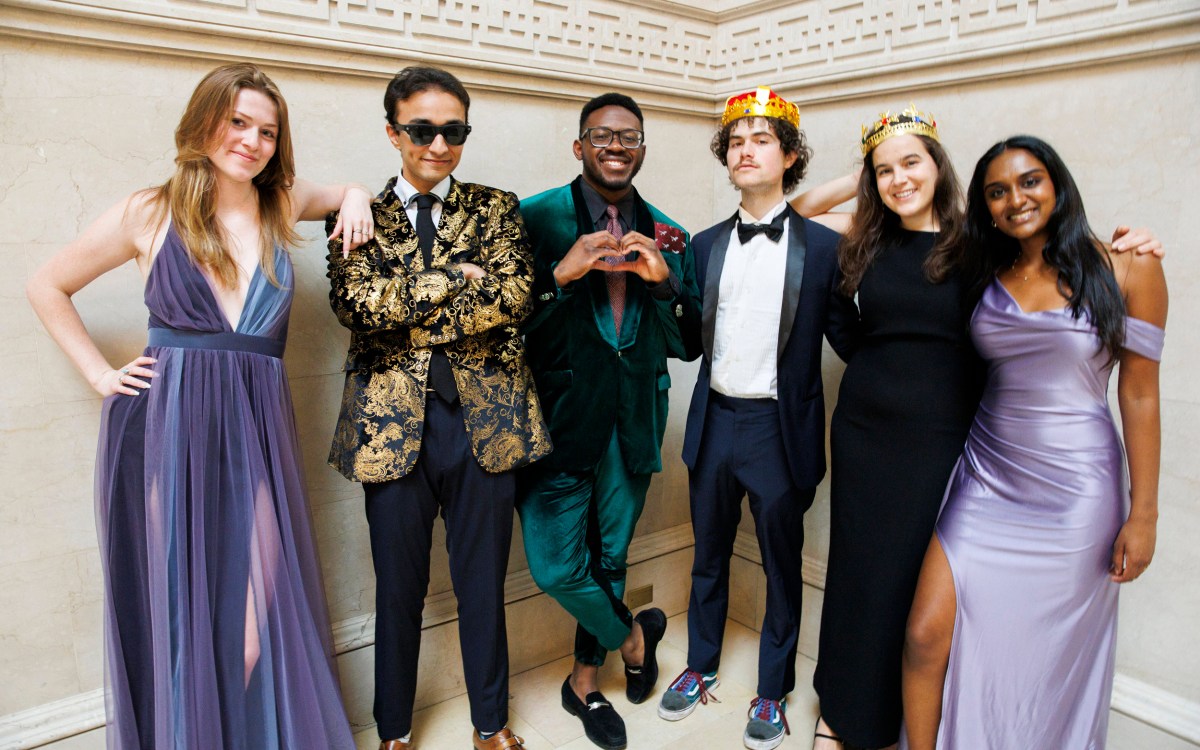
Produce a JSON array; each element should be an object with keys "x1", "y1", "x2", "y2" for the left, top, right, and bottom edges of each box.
[{"x1": 904, "y1": 136, "x2": 1166, "y2": 750}]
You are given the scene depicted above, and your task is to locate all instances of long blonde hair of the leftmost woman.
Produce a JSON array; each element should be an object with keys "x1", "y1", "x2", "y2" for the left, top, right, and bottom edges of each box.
[{"x1": 150, "y1": 62, "x2": 300, "y2": 288}]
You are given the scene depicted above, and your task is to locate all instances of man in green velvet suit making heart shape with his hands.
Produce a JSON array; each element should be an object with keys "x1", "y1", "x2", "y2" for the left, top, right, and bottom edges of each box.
[{"x1": 517, "y1": 94, "x2": 700, "y2": 748}]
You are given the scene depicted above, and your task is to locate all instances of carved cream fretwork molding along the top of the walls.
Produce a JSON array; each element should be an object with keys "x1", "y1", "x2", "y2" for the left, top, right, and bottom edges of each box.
[{"x1": 0, "y1": 0, "x2": 1200, "y2": 114}]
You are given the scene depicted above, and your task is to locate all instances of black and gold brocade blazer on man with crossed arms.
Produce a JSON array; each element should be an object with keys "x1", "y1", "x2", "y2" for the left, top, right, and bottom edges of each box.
[{"x1": 326, "y1": 178, "x2": 551, "y2": 482}]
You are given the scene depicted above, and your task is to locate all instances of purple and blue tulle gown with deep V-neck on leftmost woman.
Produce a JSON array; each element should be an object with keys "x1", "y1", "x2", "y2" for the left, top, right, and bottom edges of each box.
[{"x1": 96, "y1": 227, "x2": 354, "y2": 750}]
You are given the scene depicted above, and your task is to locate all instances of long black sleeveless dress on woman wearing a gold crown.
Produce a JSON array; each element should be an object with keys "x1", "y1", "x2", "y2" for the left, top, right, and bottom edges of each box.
[{"x1": 814, "y1": 232, "x2": 983, "y2": 748}]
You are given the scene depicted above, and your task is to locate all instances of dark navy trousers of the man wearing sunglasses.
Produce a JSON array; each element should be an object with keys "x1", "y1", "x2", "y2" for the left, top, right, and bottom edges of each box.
[{"x1": 362, "y1": 394, "x2": 516, "y2": 739}]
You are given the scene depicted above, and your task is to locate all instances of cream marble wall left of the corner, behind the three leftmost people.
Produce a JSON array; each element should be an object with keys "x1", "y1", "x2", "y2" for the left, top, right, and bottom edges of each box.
[{"x1": 0, "y1": 37, "x2": 712, "y2": 746}]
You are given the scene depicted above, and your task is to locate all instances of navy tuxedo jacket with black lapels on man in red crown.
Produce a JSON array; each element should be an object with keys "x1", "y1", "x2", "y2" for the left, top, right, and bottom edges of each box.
[{"x1": 683, "y1": 206, "x2": 858, "y2": 487}]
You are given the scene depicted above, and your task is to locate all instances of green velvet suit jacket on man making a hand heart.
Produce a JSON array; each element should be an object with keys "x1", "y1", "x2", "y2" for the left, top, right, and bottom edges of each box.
[{"x1": 521, "y1": 178, "x2": 701, "y2": 474}]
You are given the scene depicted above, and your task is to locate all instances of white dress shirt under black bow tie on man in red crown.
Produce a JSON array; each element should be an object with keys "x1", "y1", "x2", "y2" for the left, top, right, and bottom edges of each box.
[{"x1": 710, "y1": 202, "x2": 791, "y2": 398}]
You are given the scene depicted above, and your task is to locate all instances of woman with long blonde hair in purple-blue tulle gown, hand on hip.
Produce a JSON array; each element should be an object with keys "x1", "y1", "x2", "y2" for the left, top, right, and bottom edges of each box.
[{"x1": 29, "y1": 64, "x2": 373, "y2": 750}]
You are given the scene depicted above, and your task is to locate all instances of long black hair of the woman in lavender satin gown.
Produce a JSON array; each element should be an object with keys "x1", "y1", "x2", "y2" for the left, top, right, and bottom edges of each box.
[{"x1": 966, "y1": 136, "x2": 1126, "y2": 361}]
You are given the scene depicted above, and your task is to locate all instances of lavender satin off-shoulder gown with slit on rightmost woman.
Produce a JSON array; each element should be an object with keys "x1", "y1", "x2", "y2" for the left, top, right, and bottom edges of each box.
[{"x1": 937, "y1": 281, "x2": 1163, "y2": 750}]
